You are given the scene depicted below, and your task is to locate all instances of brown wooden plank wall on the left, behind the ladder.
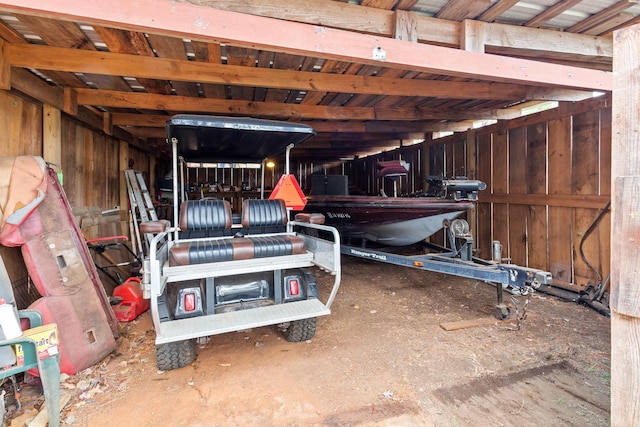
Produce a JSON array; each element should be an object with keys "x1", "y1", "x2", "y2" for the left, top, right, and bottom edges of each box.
[{"x1": 0, "y1": 91, "x2": 151, "y2": 306}]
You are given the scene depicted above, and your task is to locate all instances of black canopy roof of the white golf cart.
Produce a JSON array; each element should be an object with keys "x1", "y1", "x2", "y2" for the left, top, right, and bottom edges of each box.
[{"x1": 167, "y1": 114, "x2": 316, "y2": 162}]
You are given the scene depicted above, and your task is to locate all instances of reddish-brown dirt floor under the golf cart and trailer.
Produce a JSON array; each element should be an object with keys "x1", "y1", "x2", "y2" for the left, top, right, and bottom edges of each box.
[{"x1": 7, "y1": 257, "x2": 610, "y2": 427}]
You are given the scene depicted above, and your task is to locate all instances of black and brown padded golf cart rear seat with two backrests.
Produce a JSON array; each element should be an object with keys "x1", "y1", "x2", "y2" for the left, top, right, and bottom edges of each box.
[{"x1": 169, "y1": 199, "x2": 306, "y2": 266}]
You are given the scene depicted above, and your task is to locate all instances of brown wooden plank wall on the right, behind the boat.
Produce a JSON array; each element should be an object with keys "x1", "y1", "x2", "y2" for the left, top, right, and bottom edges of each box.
[{"x1": 328, "y1": 97, "x2": 611, "y2": 291}]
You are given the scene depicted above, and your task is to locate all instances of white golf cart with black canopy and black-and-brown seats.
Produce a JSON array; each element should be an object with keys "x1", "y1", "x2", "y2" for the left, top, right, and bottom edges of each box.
[{"x1": 140, "y1": 115, "x2": 340, "y2": 370}]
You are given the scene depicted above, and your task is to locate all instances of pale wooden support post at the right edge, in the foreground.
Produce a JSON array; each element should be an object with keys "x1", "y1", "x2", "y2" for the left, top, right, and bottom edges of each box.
[{"x1": 610, "y1": 25, "x2": 640, "y2": 426}]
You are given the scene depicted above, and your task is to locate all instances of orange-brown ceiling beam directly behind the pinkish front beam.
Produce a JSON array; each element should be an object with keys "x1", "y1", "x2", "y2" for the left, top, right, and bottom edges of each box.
[{"x1": 8, "y1": 44, "x2": 589, "y2": 101}]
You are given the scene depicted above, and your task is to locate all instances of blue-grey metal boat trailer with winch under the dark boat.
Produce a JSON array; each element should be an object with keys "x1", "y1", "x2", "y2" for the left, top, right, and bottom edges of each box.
[{"x1": 341, "y1": 219, "x2": 552, "y2": 320}]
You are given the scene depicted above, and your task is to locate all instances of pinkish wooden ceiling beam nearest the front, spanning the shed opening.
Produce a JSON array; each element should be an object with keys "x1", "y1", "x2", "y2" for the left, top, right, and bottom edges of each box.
[{"x1": 0, "y1": 0, "x2": 613, "y2": 91}]
